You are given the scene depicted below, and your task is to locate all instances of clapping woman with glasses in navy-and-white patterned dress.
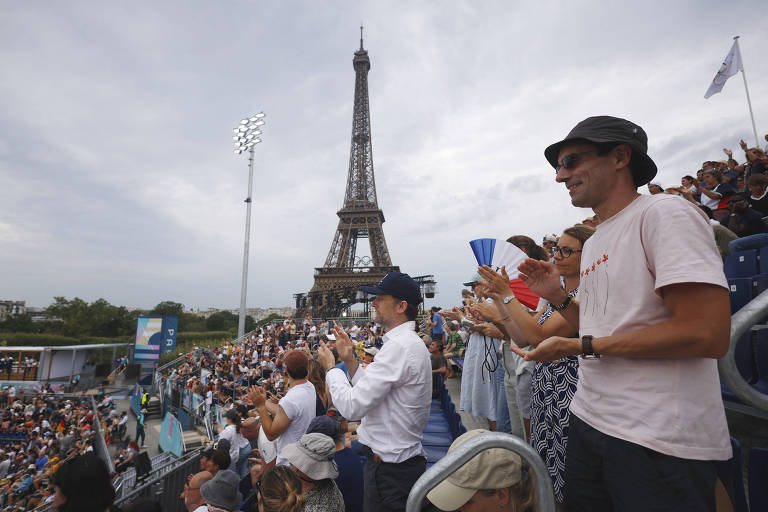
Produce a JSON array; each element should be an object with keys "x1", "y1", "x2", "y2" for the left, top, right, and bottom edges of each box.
[{"x1": 479, "y1": 225, "x2": 595, "y2": 503}]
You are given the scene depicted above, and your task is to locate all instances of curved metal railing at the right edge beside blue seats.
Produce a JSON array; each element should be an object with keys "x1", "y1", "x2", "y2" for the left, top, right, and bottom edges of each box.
[{"x1": 717, "y1": 290, "x2": 768, "y2": 411}]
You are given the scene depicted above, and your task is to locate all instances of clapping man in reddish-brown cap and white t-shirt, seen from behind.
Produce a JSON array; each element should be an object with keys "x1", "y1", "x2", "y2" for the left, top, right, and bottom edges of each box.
[{"x1": 248, "y1": 350, "x2": 317, "y2": 465}]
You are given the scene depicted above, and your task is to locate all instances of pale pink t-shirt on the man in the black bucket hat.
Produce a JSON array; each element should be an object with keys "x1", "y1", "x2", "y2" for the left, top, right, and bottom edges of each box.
[{"x1": 571, "y1": 194, "x2": 731, "y2": 460}]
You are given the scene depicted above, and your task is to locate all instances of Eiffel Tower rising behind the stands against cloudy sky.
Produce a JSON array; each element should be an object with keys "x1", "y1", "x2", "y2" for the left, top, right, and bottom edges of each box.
[{"x1": 294, "y1": 27, "x2": 400, "y2": 317}]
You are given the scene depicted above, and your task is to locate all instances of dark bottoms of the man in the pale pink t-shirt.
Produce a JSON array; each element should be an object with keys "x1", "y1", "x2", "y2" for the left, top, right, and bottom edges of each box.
[{"x1": 565, "y1": 414, "x2": 716, "y2": 512}]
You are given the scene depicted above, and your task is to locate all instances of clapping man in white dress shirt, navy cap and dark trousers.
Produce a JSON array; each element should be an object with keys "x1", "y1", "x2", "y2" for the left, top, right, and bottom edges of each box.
[{"x1": 318, "y1": 272, "x2": 432, "y2": 512}]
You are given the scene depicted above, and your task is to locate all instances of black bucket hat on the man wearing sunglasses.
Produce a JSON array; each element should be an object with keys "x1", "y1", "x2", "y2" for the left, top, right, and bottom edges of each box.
[{"x1": 544, "y1": 116, "x2": 656, "y2": 187}]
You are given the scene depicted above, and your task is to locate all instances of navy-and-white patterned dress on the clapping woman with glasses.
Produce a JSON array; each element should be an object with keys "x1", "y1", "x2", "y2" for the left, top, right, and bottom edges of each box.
[{"x1": 531, "y1": 288, "x2": 579, "y2": 503}]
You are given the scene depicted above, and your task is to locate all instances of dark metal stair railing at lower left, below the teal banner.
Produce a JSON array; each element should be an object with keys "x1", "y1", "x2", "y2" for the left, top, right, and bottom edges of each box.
[{"x1": 115, "y1": 450, "x2": 201, "y2": 512}]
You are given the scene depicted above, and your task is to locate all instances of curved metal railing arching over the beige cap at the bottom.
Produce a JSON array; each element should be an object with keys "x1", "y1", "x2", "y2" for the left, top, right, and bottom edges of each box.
[{"x1": 405, "y1": 432, "x2": 555, "y2": 512}]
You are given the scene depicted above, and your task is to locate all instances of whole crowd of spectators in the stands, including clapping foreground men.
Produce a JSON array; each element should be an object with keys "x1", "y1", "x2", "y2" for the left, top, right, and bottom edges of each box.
[{"x1": 0, "y1": 121, "x2": 768, "y2": 512}]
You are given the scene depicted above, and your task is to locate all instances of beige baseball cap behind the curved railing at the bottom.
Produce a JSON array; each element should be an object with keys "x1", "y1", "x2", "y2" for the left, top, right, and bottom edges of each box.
[{"x1": 427, "y1": 429, "x2": 522, "y2": 510}]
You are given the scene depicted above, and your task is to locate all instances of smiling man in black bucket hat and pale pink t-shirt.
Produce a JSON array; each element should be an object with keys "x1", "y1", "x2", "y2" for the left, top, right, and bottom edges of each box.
[{"x1": 520, "y1": 116, "x2": 731, "y2": 511}]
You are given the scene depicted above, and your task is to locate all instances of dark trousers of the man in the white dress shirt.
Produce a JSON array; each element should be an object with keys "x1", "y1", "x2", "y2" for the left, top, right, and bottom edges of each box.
[{"x1": 363, "y1": 445, "x2": 427, "y2": 512}]
